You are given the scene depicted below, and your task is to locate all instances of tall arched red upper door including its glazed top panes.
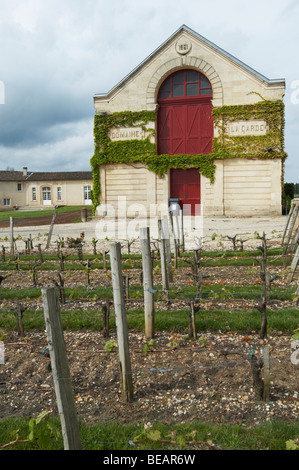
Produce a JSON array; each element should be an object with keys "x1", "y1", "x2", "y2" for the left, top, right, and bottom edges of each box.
[{"x1": 158, "y1": 69, "x2": 214, "y2": 155}]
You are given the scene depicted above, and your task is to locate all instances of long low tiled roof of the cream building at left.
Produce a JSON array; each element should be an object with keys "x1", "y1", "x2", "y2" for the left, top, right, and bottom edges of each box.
[{"x1": 0, "y1": 171, "x2": 92, "y2": 181}]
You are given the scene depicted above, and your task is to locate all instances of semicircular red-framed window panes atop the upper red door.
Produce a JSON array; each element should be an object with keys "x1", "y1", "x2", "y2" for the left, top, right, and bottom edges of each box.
[{"x1": 158, "y1": 69, "x2": 212, "y2": 102}]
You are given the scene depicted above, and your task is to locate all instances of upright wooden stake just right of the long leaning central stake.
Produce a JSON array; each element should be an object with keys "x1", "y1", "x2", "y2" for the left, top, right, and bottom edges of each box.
[{"x1": 140, "y1": 227, "x2": 155, "y2": 339}]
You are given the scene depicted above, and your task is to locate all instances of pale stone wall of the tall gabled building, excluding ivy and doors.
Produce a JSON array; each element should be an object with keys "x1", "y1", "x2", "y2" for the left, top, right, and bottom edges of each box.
[{"x1": 94, "y1": 26, "x2": 285, "y2": 216}]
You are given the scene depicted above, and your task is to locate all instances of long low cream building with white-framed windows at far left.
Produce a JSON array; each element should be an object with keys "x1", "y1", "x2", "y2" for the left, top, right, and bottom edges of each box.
[{"x1": 0, "y1": 167, "x2": 92, "y2": 210}]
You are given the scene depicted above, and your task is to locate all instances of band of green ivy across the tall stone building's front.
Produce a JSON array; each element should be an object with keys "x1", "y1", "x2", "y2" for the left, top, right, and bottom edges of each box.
[{"x1": 91, "y1": 99, "x2": 286, "y2": 211}]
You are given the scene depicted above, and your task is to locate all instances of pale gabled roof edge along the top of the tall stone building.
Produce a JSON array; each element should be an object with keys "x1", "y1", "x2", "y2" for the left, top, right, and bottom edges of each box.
[{"x1": 94, "y1": 25, "x2": 285, "y2": 98}]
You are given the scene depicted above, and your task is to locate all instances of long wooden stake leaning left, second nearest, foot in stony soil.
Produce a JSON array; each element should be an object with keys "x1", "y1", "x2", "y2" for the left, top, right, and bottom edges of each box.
[{"x1": 110, "y1": 242, "x2": 133, "y2": 402}]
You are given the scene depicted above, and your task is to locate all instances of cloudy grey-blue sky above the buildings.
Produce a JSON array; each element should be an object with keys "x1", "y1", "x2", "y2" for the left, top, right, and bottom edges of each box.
[{"x1": 0, "y1": 0, "x2": 299, "y2": 183}]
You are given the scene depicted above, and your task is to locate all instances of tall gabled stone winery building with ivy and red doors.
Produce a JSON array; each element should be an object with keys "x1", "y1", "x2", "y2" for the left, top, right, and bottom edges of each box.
[{"x1": 91, "y1": 25, "x2": 286, "y2": 217}]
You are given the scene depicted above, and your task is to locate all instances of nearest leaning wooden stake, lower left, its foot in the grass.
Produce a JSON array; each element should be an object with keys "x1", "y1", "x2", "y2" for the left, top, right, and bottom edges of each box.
[{"x1": 42, "y1": 287, "x2": 81, "y2": 450}]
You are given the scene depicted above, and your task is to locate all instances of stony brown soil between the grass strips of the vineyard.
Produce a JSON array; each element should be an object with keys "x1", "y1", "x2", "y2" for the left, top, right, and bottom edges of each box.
[{"x1": 0, "y1": 258, "x2": 299, "y2": 426}]
